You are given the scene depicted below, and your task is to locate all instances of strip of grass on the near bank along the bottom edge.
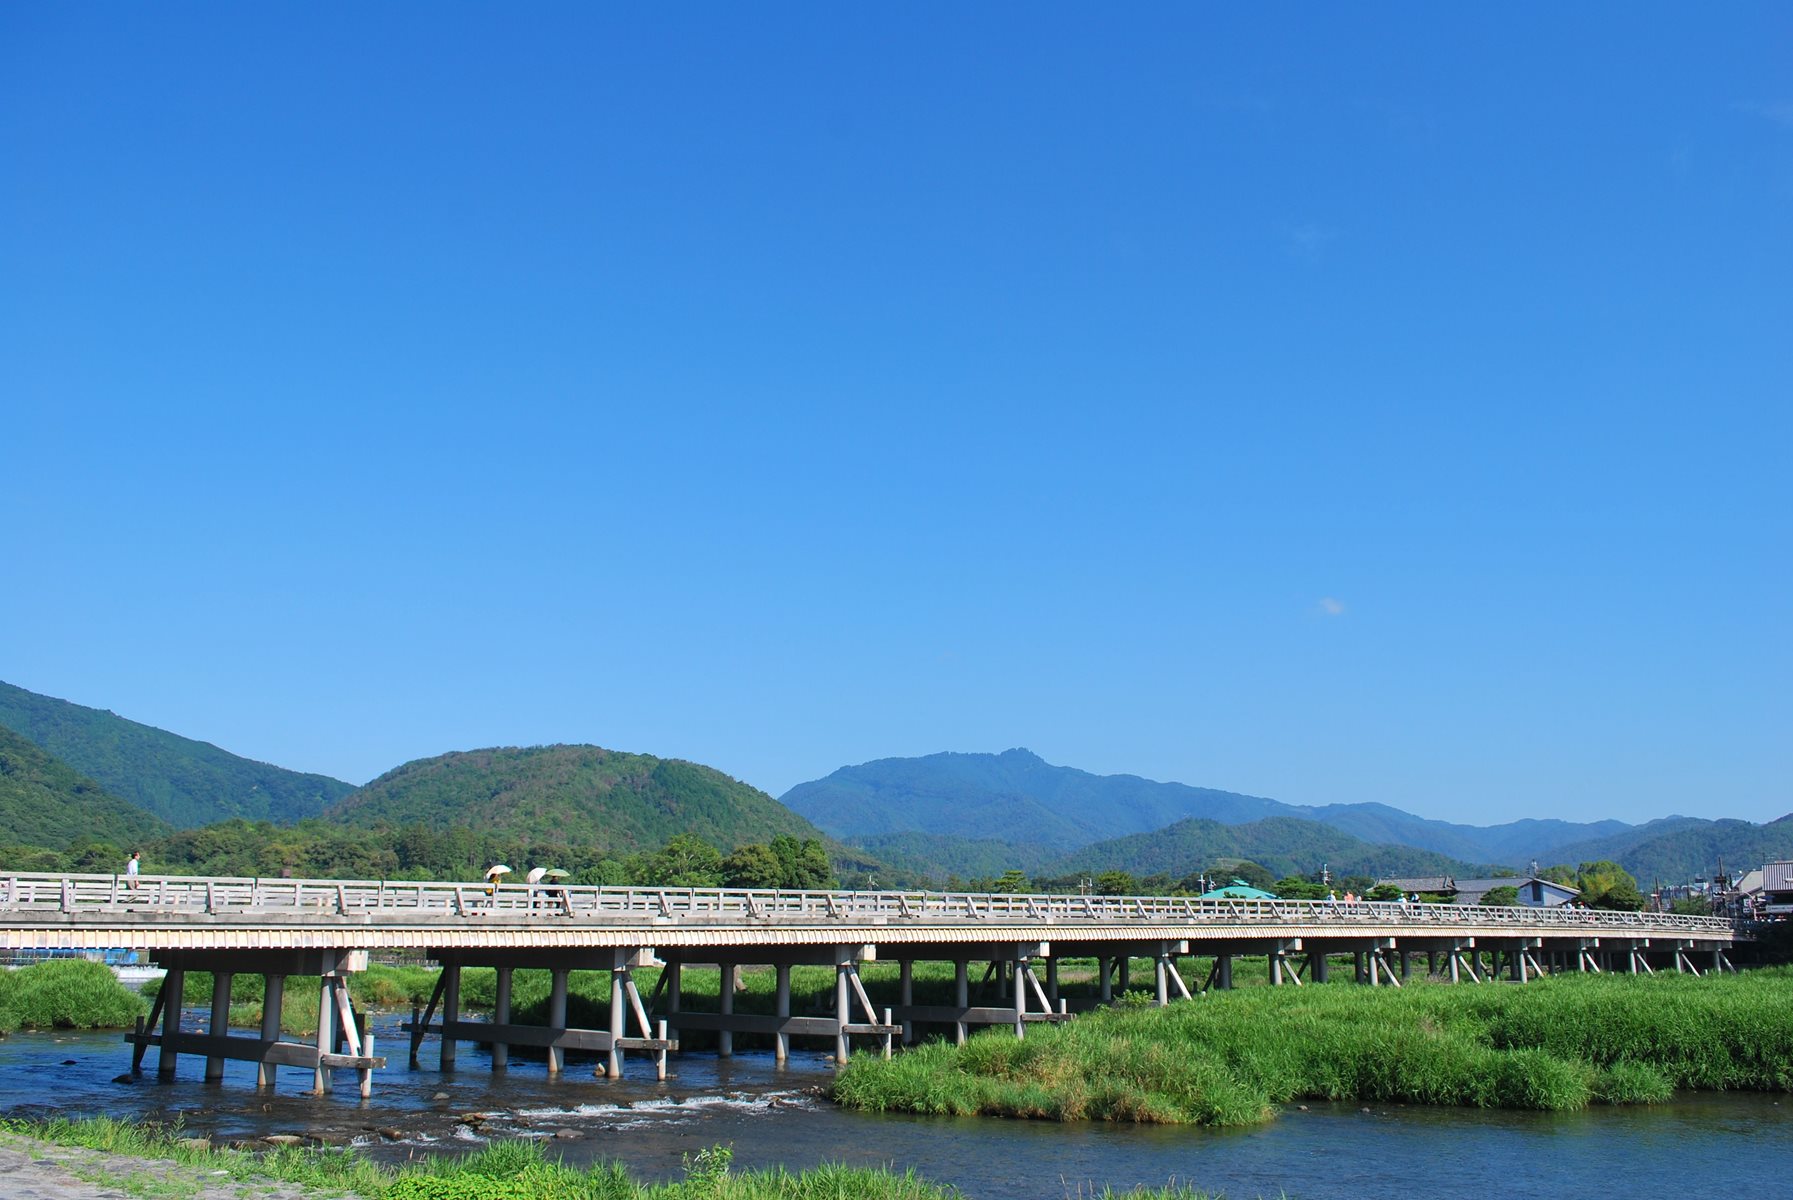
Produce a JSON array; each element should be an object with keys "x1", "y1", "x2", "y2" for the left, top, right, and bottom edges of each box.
[{"x1": 0, "y1": 1117, "x2": 1207, "y2": 1200}]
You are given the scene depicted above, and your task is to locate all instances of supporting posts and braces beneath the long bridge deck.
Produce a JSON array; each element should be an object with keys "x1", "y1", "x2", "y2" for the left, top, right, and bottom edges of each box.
[{"x1": 126, "y1": 935, "x2": 1730, "y2": 1096}]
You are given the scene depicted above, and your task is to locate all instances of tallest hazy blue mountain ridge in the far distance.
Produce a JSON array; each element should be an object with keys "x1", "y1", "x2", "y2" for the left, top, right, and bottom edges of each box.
[{"x1": 784, "y1": 750, "x2": 1691, "y2": 866}]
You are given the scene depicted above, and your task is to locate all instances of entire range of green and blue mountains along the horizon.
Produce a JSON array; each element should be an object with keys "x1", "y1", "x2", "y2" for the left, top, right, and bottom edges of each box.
[{"x1": 0, "y1": 683, "x2": 1793, "y2": 884}]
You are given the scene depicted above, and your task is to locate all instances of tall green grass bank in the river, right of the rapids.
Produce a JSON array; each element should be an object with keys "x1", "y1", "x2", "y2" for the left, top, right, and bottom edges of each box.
[{"x1": 834, "y1": 969, "x2": 1793, "y2": 1125}]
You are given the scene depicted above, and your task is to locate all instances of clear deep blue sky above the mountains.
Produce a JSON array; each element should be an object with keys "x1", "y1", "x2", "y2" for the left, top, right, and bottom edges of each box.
[{"x1": 0, "y1": 4, "x2": 1793, "y2": 823}]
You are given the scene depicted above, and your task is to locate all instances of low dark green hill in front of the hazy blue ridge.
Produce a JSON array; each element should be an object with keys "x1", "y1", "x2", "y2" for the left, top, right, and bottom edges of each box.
[{"x1": 1042, "y1": 816, "x2": 1481, "y2": 879}]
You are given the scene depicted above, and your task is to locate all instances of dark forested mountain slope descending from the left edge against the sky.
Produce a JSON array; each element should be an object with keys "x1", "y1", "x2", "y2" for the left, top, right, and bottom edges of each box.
[{"x1": 0, "y1": 683, "x2": 353, "y2": 829}]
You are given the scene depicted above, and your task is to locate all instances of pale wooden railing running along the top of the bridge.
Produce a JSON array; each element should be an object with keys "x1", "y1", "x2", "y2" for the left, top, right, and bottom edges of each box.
[{"x1": 0, "y1": 872, "x2": 1730, "y2": 935}]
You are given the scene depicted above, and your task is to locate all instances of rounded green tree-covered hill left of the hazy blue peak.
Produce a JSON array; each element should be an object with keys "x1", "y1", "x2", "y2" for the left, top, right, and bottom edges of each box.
[{"x1": 326, "y1": 746, "x2": 819, "y2": 854}]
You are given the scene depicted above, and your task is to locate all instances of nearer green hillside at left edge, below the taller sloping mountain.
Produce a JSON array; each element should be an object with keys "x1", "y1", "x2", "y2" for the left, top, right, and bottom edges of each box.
[{"x1": 0, "y1": 726, "x2": 169, "y2": 846}]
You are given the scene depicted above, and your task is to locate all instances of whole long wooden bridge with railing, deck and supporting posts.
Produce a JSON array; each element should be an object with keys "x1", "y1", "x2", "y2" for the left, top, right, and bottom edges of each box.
[{"x1": 0, "y1": 874, "x2": 1734, "y2": 1096}]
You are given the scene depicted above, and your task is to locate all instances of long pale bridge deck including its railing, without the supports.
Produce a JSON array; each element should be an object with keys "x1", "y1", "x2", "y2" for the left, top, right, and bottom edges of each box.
[{"x1": 0, "y1": 874, "x2": 1736, "y2": 956}]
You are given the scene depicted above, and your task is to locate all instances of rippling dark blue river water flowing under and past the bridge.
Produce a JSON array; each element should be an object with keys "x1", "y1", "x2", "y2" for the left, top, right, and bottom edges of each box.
[{"x1": 0, "y1": 1012, "x2": 1793, "y2": 1200}]
